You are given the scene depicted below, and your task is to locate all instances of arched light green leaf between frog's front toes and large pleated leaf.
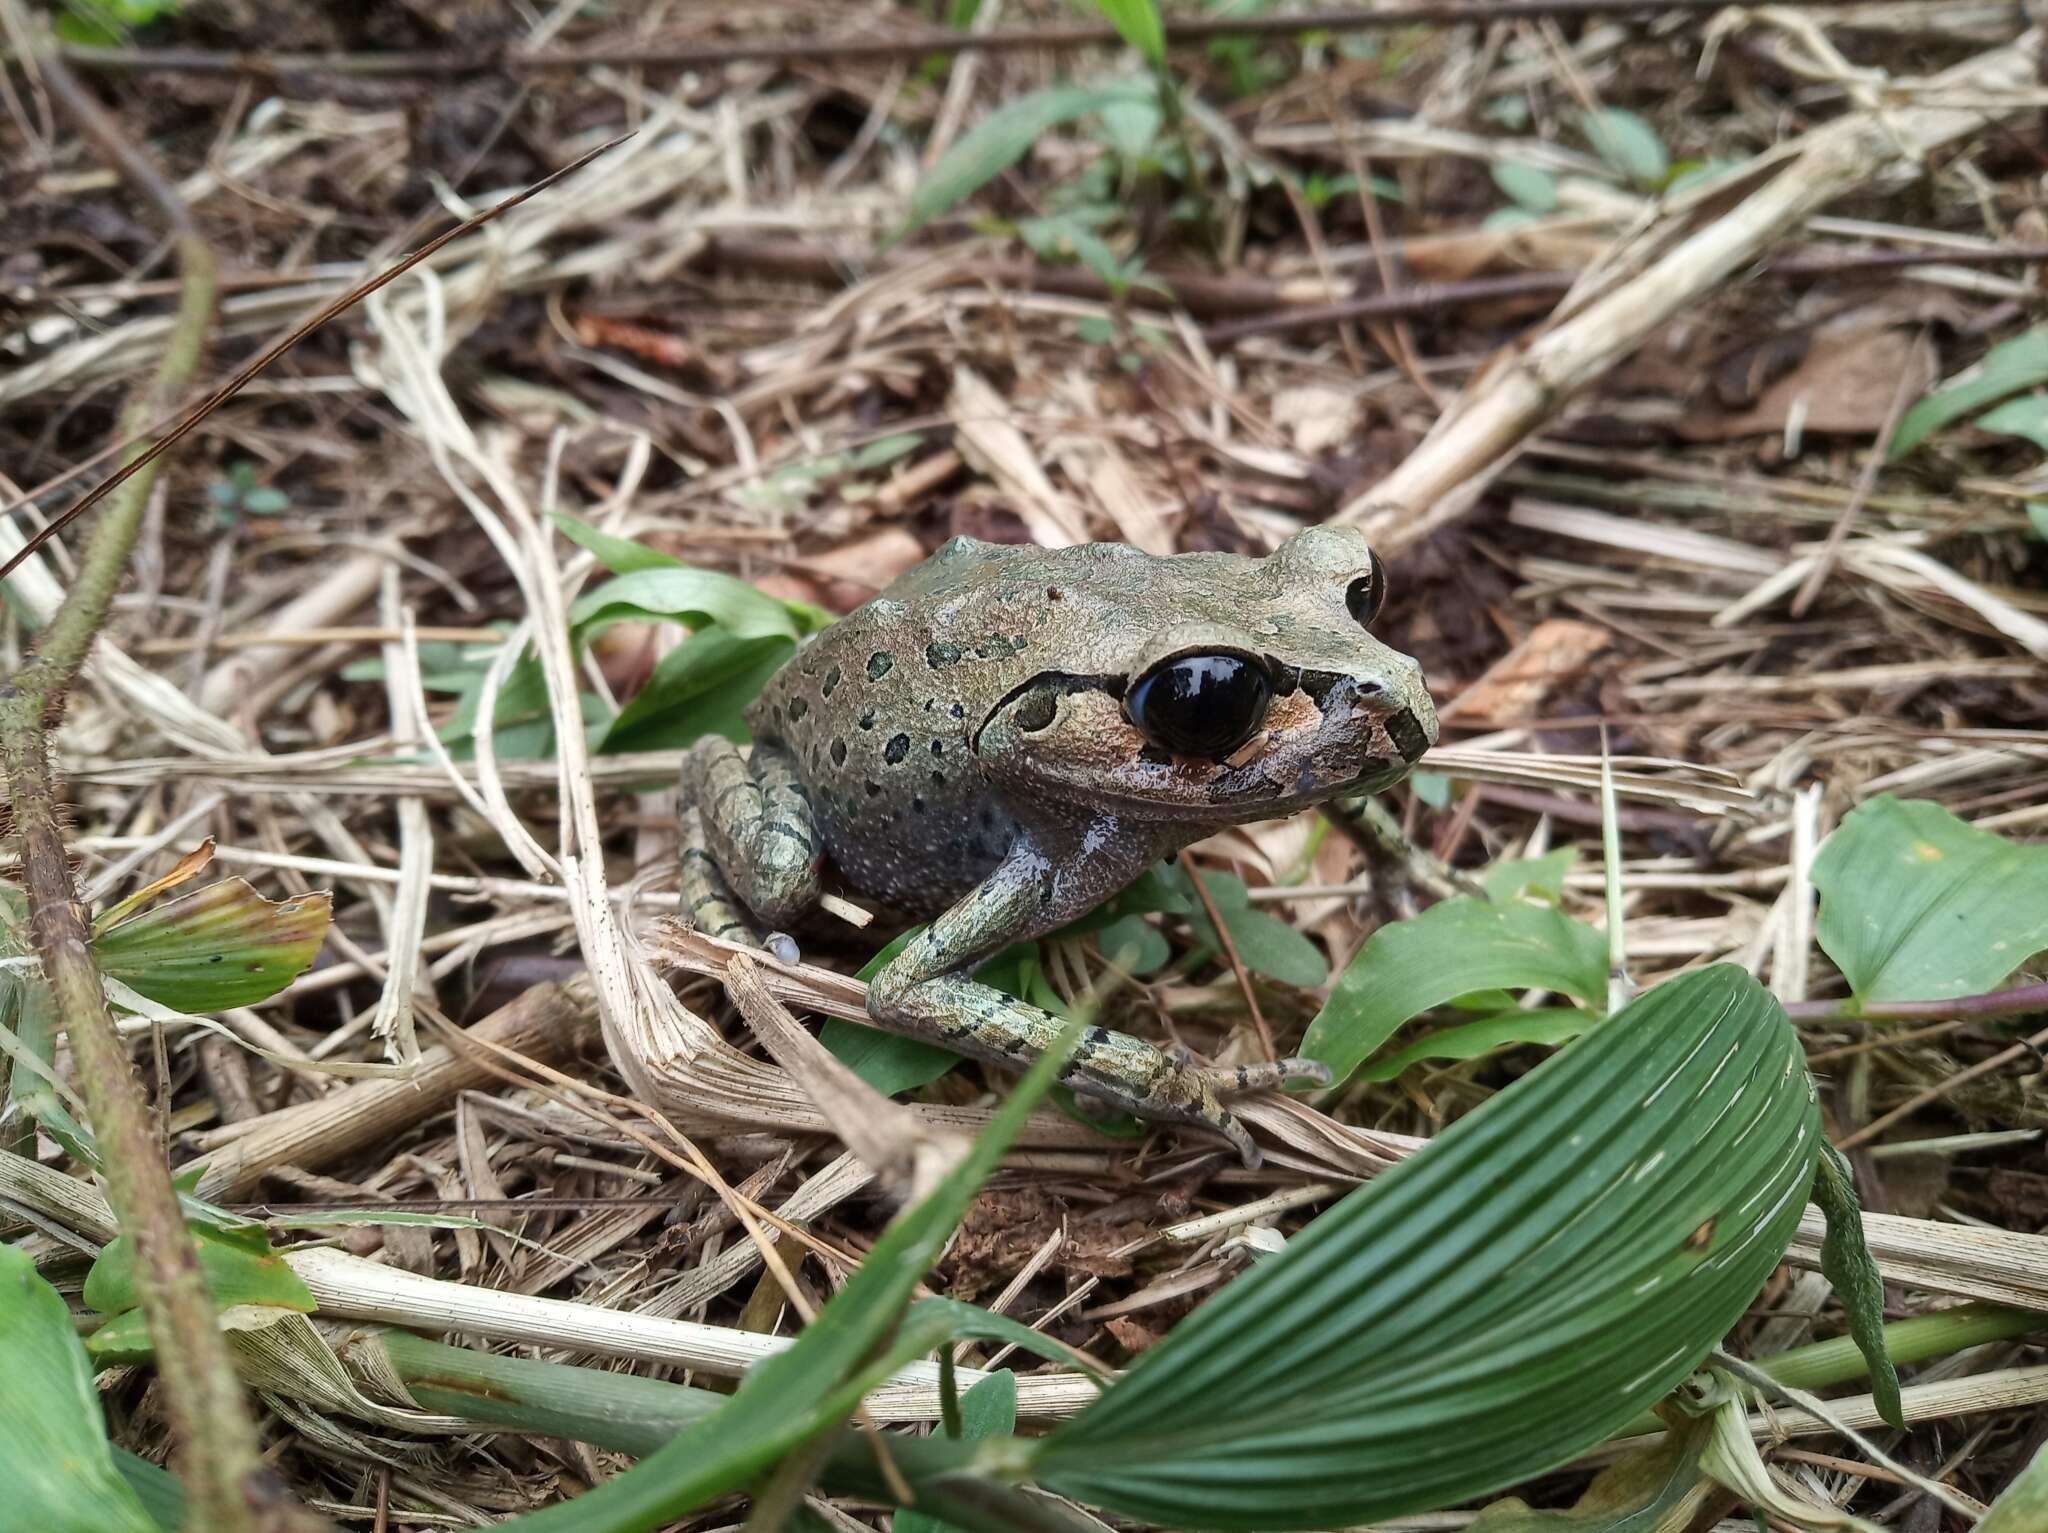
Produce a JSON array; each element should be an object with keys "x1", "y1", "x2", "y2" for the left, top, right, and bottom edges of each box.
[{"x1": 1300, "y1": 899, "x2": 1608, "y2": 1083}]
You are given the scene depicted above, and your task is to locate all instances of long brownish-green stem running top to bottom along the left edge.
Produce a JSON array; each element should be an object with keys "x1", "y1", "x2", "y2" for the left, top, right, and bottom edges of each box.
[{"x1": 0, "y1": 29, "x2": 326, "y2": 1533}]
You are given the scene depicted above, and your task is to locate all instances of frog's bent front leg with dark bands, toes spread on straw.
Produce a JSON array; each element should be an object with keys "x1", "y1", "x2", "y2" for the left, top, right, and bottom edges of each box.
[{"x1": 868, "y1": 819, "x2": 1327, "y2": 1167}]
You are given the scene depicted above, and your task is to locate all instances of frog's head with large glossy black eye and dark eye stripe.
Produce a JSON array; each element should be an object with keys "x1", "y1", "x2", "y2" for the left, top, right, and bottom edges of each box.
[{"x1": 973, "y1": 526, "x2": 1436, "y2": 823}]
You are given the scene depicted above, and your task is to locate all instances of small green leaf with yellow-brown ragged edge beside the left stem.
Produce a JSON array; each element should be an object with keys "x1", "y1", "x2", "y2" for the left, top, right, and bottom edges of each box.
[{"x1": 92, "y1": 878, "x2": 334, "y2": 1011}]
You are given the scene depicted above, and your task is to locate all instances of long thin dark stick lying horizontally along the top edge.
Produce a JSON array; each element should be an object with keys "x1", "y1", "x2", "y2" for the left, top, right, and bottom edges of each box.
[{"x1": 48, "y1": 0, "x2": 1892, "y2": 80}]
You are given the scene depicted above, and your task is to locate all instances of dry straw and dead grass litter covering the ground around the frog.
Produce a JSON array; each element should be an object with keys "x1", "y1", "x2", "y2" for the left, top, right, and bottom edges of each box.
[{"x1": 0, "y1": 0, "x2": 2048, "y2": 1529}]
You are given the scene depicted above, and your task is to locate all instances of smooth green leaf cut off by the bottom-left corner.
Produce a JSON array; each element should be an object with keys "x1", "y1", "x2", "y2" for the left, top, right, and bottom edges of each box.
[{"x1": 0, "y1": 1246, "x2": 156, "y2": 1533}]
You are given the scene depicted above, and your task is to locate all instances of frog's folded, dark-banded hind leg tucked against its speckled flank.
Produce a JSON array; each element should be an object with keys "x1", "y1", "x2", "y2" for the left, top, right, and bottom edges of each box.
[{"x1": 682, "y1": 735, "x2": 823, "y2": 931}]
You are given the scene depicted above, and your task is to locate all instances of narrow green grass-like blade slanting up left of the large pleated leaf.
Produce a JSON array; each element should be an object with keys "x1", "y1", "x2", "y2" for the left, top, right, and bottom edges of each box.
[{"x1": 502, "y1": 1021, "x2": 1081, "y2": 1533}]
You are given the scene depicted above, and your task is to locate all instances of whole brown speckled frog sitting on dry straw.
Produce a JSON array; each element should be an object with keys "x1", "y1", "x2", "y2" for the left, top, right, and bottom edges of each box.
[{"x1": 678, "y1": 524, "x2": 1438, "y2": 1167}]
